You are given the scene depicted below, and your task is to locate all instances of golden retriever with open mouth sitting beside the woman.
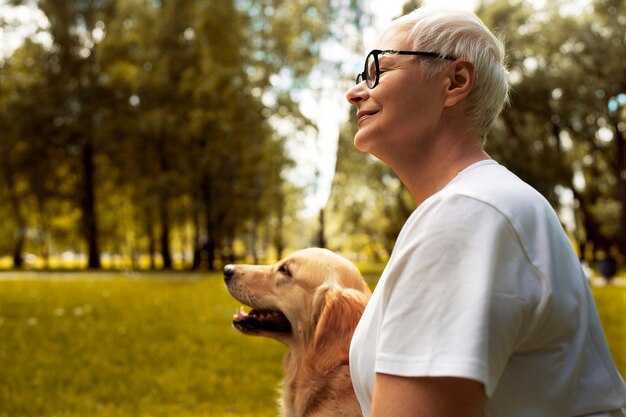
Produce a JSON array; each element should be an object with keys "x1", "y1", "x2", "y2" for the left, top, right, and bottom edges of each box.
[{"x1": 224, "y1": 248, "x2": 371, "y2": 417}]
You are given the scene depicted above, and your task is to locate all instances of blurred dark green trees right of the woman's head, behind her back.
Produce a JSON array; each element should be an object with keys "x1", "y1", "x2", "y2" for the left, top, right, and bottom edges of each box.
[{"x1": 478, "y1": 0, "x2": 626, "y2": 257}]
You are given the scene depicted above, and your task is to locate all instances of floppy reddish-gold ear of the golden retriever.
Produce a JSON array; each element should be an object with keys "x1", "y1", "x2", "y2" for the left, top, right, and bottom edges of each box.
[{"x1": 308, "y1": 287, "x2": 367, "y2": 374}]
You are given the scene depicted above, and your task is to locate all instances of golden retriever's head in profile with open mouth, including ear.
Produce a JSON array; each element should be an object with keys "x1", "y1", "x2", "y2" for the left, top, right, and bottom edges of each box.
[{"x1": 224, "y1": 248, "x2": 370, "y2": 349}]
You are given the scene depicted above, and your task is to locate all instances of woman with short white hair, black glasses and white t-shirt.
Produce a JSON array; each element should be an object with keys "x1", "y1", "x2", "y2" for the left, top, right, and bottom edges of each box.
[{"x1": 347, "y1": 7, "x2": 626, "y2": 417}]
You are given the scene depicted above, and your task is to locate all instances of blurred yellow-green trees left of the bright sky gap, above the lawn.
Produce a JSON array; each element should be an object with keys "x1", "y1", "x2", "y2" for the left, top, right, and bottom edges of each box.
[{"x1": 0, "y1": 0, "x2": 342, "y2": 268}]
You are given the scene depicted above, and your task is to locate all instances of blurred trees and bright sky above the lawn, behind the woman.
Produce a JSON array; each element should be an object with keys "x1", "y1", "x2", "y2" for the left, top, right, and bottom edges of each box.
[{"x1": 0, "y1": 0, "x2": 626, "y2": 269}]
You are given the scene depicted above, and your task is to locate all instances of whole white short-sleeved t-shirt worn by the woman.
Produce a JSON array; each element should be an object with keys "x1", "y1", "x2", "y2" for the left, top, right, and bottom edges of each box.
[{"x1": 350, "y1": 160, "x2": 626, "y2": 417}]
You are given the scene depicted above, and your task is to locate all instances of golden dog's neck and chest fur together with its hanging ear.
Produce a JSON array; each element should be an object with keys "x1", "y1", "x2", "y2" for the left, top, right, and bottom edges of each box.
[{"x1": 281, "y1": 280, "x2": 369, "y2": 417}]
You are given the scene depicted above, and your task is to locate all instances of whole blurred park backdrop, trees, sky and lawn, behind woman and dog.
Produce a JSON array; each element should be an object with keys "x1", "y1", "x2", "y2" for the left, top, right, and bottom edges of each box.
[{"x1": 0, "y1": 0, "x2": 626, "y2": 417}]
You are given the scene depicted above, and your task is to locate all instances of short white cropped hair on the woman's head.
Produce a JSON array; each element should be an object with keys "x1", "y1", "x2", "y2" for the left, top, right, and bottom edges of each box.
[{"x1": 387, "y1": 6, "x2": 509, "y2": 138}]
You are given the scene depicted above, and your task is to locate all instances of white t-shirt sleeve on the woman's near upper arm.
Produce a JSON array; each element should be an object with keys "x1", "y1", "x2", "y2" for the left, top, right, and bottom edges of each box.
[{"x1": 375, "y1": 195, "x2": 537, "y2": 396}]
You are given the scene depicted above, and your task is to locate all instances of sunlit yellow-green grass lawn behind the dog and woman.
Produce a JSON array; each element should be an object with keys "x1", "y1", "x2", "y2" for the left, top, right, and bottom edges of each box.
[{"x1": 0, "y1": 273, "x2": 626, "y2": 417}]
